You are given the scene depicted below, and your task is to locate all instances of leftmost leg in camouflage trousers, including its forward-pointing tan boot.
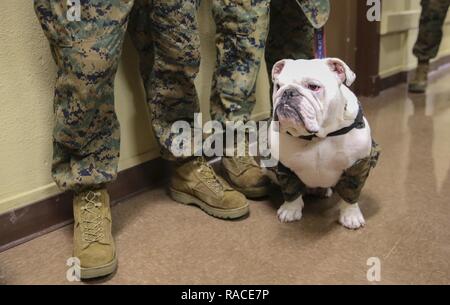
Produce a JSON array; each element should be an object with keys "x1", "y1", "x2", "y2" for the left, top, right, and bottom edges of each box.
[{"x1": 34, "y1": 0, "x2": 133, "y2": 278}]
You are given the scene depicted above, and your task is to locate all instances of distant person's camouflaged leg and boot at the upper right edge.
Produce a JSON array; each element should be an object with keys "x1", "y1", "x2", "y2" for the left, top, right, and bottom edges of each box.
[{"x1": 409, "y1": 0, "x2": 450, "y2": 93}]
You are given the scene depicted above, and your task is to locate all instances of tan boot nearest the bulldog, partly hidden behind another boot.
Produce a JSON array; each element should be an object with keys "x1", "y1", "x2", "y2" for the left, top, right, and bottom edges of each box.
[{"x1": 222, "y1": 149, "x2": 270, "y2": 198}]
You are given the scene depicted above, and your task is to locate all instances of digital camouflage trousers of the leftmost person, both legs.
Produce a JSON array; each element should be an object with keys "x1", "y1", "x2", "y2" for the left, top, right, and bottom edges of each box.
[{"x1": 34, "y1": 0, "x2": 200, "y2": 191}]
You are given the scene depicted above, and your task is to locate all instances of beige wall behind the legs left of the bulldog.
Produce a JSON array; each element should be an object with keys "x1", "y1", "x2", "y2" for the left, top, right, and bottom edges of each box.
[{"x1": 0, "y1": 0, "x2": 269, "y2": 213}]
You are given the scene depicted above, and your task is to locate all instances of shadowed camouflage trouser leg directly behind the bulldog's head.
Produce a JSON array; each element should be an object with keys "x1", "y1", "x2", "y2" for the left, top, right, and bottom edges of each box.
[{"x1": 266, "y1": 0, "x2": 314, "y2": 76}]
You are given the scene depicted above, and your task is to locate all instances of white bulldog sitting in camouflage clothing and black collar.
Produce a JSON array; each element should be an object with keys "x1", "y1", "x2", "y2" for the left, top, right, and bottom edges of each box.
[{"x1": 270, "y1": 58, "x2": 379, "y2": 230}]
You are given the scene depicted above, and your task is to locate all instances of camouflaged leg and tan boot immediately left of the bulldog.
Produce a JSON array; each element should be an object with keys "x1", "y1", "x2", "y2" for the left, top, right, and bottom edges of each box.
[{"x1": 211, "y1": 0, "x2": 270, "y2": 198}]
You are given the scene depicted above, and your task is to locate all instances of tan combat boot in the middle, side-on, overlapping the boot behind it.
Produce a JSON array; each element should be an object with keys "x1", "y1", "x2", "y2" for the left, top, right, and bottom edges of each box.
[{"x1": 170, "y1": 158, "x2": 249, "y2": 219}]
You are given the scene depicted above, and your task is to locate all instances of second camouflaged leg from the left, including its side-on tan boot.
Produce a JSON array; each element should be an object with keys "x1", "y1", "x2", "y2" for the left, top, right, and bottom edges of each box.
[{"x1": 130, "y1": 0, "x2": 249, "y2": 219}]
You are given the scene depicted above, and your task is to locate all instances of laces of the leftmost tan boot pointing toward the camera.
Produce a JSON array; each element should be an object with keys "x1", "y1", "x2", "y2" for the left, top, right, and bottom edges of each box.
[{"x1": 80, "y1": 191, "x2": 105, "y2": 243}]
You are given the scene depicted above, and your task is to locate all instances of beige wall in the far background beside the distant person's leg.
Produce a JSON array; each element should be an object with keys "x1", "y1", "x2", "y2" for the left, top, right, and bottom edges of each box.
[{"x1": 380, "y1": 0, "x2": 450, "y2": 78}]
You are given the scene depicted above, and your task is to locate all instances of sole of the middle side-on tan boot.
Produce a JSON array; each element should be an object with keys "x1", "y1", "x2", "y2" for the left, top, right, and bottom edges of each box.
[{"x1": 169, "y1": 188, "x2": 250, "y2": 219}]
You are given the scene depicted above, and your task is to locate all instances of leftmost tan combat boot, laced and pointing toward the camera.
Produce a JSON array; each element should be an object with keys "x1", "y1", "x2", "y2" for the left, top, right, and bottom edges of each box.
[{"x1": 73, "y1": 189, "x2": 117, "y2": 279}]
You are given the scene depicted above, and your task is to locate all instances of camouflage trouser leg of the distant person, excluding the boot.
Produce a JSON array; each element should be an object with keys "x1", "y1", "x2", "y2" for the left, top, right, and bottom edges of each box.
[{"x1": 413, "y1": 0, "x2": 450, "y2": 61}]
